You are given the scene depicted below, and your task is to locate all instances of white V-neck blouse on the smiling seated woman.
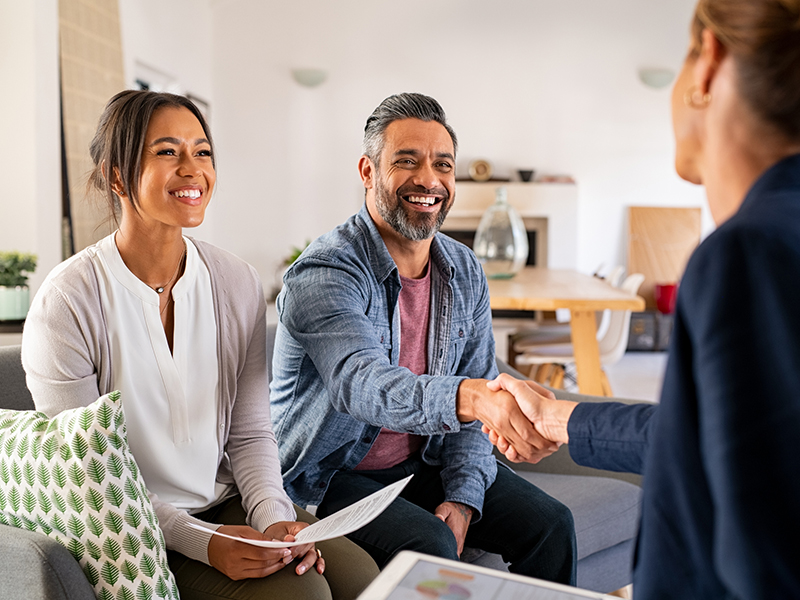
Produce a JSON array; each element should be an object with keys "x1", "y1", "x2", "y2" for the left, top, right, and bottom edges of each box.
[{"x1": 93, "y1": 234, "x2": 230, "y2": 512}]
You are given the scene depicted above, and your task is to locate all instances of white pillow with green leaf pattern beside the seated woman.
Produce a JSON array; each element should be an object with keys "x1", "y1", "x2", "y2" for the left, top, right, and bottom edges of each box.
[{"x1": 0, "y1": 392, "x2": 178, "y2": 600}]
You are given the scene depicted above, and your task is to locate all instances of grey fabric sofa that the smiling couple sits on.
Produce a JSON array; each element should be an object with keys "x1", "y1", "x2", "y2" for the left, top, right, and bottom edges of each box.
[{"x1": 0, "y1": 338, "x2": 641, "y2": 600}]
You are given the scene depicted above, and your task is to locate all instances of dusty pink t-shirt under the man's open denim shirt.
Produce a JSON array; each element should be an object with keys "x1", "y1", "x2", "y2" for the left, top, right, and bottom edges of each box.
[{"x1": 356, "y1": 268, "x2": 431, "y2": 470}]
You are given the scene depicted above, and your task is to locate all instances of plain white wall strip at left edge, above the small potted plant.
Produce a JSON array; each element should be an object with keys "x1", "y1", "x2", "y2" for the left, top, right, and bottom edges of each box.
[{"x1": 0, "y1": 0, "x2": 61, "y2": 291}]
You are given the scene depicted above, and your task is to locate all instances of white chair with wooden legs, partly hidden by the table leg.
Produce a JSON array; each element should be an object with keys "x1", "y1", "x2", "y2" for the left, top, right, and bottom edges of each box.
[{"x1": 514, "y1": 273, "x2": 644, "y2": 396}]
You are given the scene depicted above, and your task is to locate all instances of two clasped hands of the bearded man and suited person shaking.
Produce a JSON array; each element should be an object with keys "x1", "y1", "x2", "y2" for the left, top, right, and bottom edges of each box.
[{"x1": 457, "y1": 374, "x2": 577, "y2": 463}]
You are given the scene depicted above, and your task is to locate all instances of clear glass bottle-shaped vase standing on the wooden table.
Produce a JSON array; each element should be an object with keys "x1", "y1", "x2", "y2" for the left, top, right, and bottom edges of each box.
[{"x1": 473, "y1": 187, "x2": 528, "y2": 279}]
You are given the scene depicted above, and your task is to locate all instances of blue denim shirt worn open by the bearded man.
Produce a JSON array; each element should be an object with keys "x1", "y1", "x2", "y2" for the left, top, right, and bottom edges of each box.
[{"x1": 270, "y1": 207, "x2": 497, "y2": 520}]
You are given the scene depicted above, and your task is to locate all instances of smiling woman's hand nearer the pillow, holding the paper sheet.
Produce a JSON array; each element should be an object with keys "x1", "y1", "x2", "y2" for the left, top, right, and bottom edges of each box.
[{"x1": 208, "y1": 525, "x2": 294, "y2": 581}]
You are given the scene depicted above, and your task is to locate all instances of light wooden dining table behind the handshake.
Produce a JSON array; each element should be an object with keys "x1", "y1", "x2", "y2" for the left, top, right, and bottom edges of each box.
[{"x1": 488, "y1": 267, "x2": 645, "y2": 396}]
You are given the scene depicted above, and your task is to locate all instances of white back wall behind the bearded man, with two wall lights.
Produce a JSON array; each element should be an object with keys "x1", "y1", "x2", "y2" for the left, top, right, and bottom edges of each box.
[{"x1": 198, "y1": 0, "x2": 703, "y2": 290}]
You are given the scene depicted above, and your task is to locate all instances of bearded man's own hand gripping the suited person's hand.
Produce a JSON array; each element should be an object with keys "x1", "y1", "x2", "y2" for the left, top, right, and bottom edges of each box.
[{"x1": 456, "y1": 378, "x2": 558, "y2": 463}]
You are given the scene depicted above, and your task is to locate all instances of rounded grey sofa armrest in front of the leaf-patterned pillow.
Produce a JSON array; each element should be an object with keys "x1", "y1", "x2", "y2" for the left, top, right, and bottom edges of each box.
[{"x1": 0, "y1": 525, "x2": 95, "y2": 600}]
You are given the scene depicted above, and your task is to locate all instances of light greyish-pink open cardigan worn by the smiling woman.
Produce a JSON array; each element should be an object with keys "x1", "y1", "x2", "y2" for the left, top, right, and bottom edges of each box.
[{"x1": 22, "y1": 240, "x2": 296, "y2": 564}]
